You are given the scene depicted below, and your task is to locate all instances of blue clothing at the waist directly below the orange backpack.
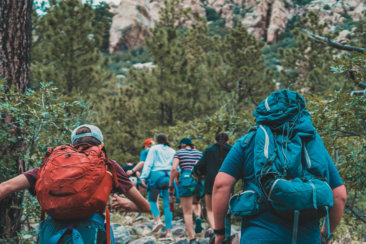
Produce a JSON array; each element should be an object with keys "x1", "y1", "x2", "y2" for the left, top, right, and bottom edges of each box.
[{"x1": 39, "y1": 213, "x2": 114, "y2": 244}]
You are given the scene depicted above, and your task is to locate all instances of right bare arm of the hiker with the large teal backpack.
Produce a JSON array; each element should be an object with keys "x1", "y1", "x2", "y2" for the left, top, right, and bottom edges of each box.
[{"x1": 329, "y1": 185, "x2": 347, "y2": 233}]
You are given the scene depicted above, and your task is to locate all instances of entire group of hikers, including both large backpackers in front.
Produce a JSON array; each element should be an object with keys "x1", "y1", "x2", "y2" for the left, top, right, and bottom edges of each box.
[{"x1": 0, "y1": 90, "x2": 347, "y2": 244}]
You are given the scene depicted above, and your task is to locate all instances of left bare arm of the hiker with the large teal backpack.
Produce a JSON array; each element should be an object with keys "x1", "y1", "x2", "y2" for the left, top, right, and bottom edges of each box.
[{"x1": 212, "y1": 172, "x2": 236, "y2": 243}]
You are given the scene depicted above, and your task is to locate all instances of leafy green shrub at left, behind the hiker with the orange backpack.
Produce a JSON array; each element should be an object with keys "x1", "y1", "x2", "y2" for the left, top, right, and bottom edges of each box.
[{"x1": 0, "y1": 81, "x2": 86, "y2": 182}]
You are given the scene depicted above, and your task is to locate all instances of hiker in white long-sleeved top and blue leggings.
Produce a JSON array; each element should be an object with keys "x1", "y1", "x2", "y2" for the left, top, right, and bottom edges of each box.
[{"x1": 140, "y1": 133, "x2": 175, "y2": 240}]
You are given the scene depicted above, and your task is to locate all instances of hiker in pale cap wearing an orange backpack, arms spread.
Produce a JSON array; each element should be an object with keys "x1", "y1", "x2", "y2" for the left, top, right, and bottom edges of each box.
[{"x1": 0, "y1": 125, "x2": 150, "y2": 243}]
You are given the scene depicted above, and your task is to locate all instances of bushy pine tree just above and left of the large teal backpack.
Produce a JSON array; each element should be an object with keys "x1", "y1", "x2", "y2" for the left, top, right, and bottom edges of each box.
[{"x1": 220, "y1": 23, "x2": 275, "y2": 106}]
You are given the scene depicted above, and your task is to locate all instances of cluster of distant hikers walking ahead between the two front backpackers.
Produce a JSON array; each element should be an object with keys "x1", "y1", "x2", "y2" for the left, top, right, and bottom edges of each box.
[{"x1": 122, "y1": 132, "x2": 231, "y2": 243}]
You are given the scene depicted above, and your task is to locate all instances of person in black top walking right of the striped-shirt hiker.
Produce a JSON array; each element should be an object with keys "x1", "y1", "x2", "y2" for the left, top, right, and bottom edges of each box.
[{"x1": 193, "y1": 131, "x2": 231, "y2": 234}]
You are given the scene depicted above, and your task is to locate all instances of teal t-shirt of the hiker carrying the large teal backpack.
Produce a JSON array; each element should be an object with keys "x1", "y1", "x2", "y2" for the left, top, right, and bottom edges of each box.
[{"x1": 220, "y1": 136, "x2": 343, "y2": 244}]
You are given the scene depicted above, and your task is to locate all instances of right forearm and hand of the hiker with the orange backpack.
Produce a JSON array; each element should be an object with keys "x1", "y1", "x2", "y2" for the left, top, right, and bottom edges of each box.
[{"x1": 112, "y1": 187, "x2": 150, "y2": 212}]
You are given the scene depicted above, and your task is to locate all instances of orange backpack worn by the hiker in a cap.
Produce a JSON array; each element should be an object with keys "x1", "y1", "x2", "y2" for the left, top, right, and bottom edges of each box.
[{"x1": 36, "y1": 144, "x2": 118, "y2": 219}]
